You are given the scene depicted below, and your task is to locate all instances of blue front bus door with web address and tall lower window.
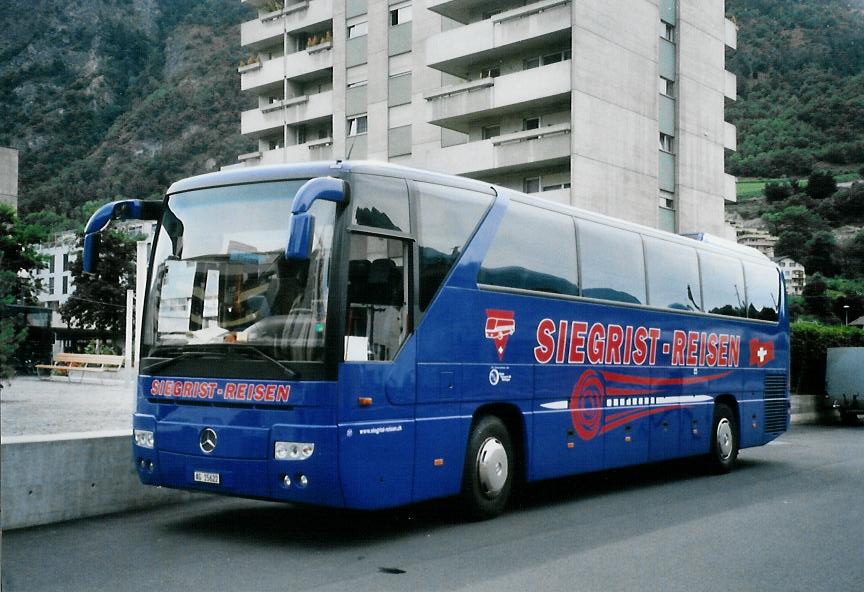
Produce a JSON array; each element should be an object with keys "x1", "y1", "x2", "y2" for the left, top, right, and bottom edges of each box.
[{"x1": 339, "y1": 232, "x2": 416, "y2": 509}]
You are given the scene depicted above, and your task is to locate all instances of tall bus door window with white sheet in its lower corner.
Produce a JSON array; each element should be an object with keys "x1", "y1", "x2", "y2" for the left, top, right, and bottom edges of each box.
[{"x1": 345, "y1": 233, "x2": 410, "y2": 361}]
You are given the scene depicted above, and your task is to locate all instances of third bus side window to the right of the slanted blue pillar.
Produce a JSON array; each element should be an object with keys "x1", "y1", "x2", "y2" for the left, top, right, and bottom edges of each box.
[{"x1": 644, "y1": 237, "x2": 702, "y2": 310}]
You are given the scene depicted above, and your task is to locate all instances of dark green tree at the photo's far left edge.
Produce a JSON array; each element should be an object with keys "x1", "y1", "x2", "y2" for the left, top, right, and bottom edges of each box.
[{"x1": 0, "y1": 204, "x2": 46, "y2": 379}]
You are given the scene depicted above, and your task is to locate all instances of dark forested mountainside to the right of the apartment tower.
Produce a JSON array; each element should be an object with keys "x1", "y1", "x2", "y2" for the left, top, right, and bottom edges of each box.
[{"x1": 726, "y1": 0, "x2": 864, "y2": 177}]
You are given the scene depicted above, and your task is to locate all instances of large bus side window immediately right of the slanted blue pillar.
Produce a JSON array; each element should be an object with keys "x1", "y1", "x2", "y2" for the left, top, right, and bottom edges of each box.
[{"x1": 477, "y1": 203, "x2": 579, "y2": 296}]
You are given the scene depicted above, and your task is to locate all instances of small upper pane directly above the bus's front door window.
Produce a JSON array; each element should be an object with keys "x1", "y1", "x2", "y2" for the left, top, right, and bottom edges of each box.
[{"x1": 351, "y1": 174, "x2": 411, "y2": 233}]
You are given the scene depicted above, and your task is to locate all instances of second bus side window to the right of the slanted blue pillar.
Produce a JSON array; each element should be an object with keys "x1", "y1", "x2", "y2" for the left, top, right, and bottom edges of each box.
[{"x1": 579, "y1": 220, "x2": 645, "y2": 304}]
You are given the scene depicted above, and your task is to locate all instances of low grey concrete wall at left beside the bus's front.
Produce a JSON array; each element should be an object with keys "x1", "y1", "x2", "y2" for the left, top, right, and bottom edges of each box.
[{"x1": 0, "y1": 431, "x2": 194, "y2": 530}]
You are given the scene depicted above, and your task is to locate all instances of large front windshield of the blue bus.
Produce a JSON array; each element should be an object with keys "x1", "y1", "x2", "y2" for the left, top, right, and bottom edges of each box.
[{"x1": 142, "y1": 180, "x2": 336, "y2": 364}]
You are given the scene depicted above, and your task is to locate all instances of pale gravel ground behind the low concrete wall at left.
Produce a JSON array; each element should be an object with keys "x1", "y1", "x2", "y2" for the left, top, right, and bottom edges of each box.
[{"x1": 0, "y1": 375, "x2": 135, "y2": 439}]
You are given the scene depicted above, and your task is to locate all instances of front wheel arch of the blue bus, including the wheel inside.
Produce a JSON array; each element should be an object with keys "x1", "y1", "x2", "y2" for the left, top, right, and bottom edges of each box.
[{"x1": 461, "y1": 405, "x2": 525, "y2": 520}]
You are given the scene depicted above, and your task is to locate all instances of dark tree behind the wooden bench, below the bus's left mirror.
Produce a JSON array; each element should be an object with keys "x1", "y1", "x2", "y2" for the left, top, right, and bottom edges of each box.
[{"x1": 60, "y1": 231, "x2": 135, "y2": 333}]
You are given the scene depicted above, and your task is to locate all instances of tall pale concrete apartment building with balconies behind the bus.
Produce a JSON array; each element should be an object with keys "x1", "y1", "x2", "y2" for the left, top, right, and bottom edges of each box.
[{"x1": 237, "y1": 0, "x2": 737, "y2": 235}]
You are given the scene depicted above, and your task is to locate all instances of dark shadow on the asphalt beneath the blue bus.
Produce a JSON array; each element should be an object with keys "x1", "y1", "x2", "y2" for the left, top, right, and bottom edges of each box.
[{"x1": 164, "y1": 459, "x2": 782, "y2": 549}]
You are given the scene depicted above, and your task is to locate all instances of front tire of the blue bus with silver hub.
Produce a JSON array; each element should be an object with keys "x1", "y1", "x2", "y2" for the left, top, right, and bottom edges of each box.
[{"x1": 462, "y1": 415, "x2": 516, "y2": 520}]
